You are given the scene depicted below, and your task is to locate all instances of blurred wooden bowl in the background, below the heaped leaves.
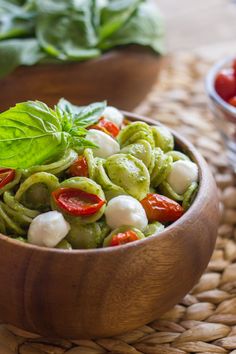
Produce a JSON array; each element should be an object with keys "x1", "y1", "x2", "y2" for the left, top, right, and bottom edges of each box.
[{"x1": 0, "y1": 46, "x2": 161, "y2": 111}]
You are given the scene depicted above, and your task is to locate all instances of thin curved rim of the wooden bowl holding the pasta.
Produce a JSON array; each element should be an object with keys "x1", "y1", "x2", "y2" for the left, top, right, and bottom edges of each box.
[{"x1": 0, "y1": 111, "x2": 206, "y2": 255}]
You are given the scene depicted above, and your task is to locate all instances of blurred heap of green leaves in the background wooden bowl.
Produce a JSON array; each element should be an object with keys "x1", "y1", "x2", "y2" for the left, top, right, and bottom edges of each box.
[{"x1": 0, "y1": 0, "x2": 163, "y2": 77}]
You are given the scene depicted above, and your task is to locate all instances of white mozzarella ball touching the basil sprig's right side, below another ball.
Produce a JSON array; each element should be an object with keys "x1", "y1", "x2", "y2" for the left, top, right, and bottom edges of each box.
[{"x1": 86, "y1": 129, "x2": 120, "y2": 158}]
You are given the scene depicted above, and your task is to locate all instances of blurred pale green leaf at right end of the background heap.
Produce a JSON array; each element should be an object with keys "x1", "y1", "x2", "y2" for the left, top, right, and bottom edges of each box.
[{"x1": 100, "y1": 2, "x2": 164, "y2": 54}]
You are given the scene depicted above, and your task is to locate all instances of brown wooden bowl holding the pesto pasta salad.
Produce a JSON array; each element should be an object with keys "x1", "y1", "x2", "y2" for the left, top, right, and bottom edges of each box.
[{"x1": 0, "y1": 114, "x2": 219, "y2": 338}]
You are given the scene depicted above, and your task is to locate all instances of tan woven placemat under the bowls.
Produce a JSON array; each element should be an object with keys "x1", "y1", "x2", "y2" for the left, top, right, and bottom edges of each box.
[{"x1": 0, "y1": 47, "x2": 236, "y2": 354}]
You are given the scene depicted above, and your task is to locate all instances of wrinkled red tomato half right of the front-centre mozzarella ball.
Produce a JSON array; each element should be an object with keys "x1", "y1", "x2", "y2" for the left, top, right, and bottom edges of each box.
[{"x1": 141, "y1": 193, "x2": 184, "y2": 222}]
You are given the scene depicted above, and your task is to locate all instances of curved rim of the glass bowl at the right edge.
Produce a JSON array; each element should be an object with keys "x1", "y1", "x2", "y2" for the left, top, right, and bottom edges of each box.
[{"x1": 205, "y1": 55, "x2": 236, "y2": 122}]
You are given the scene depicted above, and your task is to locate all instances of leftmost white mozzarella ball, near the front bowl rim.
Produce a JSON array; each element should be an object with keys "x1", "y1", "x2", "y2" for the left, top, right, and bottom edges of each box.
[{"x1": 28, "y1": 211, "x2": 70, "y2": 247}]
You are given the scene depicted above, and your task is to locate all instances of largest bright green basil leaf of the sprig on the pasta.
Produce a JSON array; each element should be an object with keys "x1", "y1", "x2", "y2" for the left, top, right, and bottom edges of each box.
[{"x1": 0, "y1": 102, "x2": 71, "y2": 168}]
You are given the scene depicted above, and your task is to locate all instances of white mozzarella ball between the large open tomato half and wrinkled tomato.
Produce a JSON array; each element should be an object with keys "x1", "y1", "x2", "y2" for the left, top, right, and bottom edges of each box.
[{"x1": 105, "y1": 195, "x2": 148, "y2": 230}]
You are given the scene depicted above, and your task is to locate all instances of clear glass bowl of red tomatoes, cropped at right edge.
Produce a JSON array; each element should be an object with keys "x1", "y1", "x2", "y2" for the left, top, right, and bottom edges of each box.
[{"x1": 206, "y1": 56, "x2": 236, "y2": 173}]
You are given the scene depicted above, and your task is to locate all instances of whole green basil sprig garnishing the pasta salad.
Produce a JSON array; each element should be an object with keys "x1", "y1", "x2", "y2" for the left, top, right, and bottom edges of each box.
[{"x1": 0, "y1": 100, "x2": 106, "y2": 169}]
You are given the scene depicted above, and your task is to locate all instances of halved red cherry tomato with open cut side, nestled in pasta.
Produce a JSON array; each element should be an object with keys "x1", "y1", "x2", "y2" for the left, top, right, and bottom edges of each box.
[{"x1": 52, "y1": 188, "x2": 105, "y2": 216}]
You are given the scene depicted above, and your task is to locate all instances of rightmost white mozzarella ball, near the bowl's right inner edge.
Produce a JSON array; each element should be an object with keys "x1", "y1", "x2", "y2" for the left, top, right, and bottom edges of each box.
[{"x1": 167, "y1": 160, "x2": 198, "y2": 194}]
